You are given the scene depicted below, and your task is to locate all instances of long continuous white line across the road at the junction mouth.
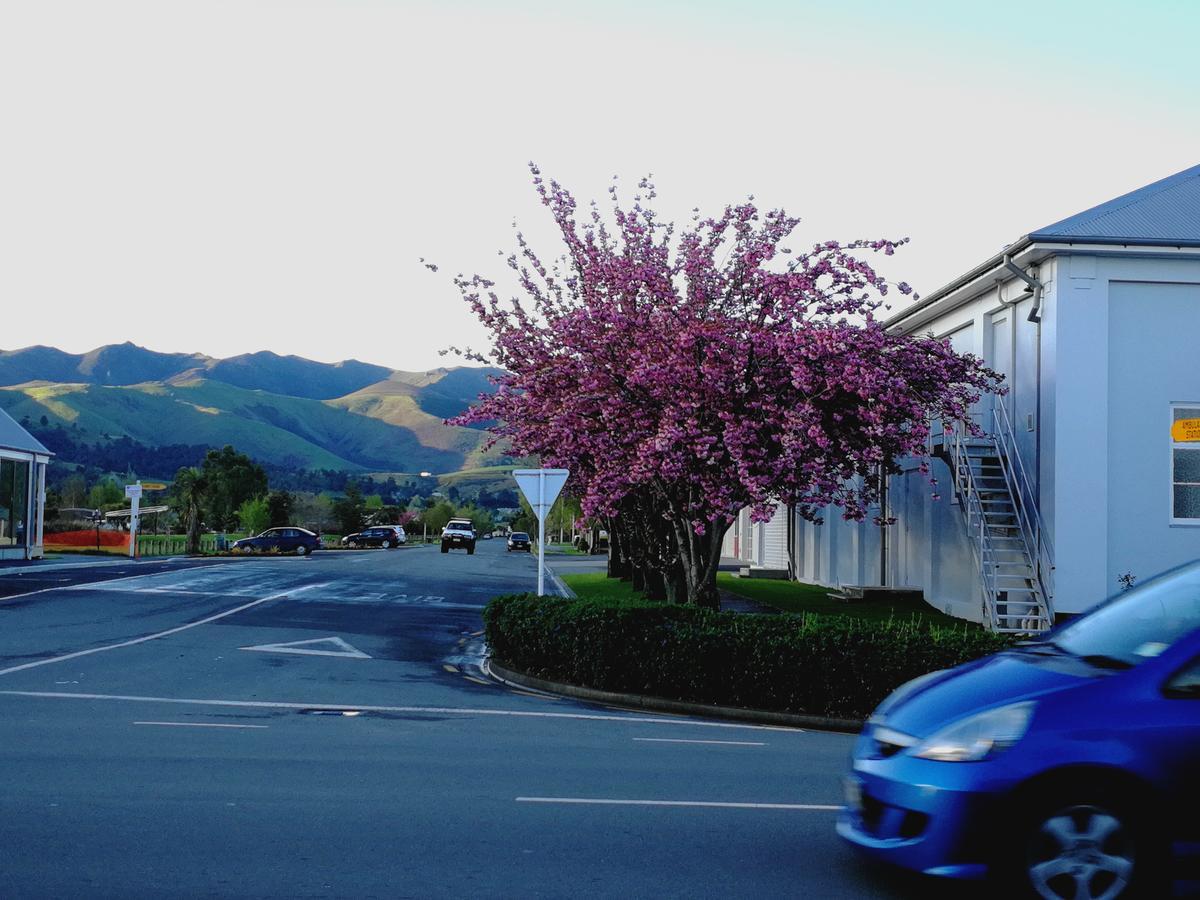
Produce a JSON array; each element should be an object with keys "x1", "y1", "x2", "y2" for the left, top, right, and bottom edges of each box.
[{"x1": 0, "y1": 696, "x2": 803, "y2": 734}]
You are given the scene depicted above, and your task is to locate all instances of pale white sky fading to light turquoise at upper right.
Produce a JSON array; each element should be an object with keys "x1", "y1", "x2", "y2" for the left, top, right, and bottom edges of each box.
[{"x1": 0, "y1": 0, "x2": 1200, "y2": 371}]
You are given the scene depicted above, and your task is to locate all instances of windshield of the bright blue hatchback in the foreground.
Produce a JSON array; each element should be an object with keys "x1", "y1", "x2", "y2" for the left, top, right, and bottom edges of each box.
[{"x1": 1028, "y1": 563, "x2": 1200, "y2": 667}]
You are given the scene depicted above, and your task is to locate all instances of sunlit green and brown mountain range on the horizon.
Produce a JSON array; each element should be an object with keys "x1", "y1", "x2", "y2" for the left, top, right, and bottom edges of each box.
[{"x1": 0, "y1": 343, "x2": 500, "y2": 476}]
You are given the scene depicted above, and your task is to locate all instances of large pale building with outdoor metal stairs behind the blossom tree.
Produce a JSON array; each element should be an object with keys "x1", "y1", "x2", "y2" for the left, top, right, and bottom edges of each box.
[{"x1": 726, "y1": 166, "x2": 1200, "y2": 630}]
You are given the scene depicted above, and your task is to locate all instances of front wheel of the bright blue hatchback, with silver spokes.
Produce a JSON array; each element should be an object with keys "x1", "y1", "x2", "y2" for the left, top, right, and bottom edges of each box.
[{"x1": 1020, "y1": 790, "x2": 1162, "y2": 900}]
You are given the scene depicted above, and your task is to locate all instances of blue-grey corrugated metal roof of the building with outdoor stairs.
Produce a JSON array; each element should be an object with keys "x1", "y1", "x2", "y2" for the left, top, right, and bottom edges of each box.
[{"x1": 1030, "y1": 166, "x2": 1200, "y2": 246}]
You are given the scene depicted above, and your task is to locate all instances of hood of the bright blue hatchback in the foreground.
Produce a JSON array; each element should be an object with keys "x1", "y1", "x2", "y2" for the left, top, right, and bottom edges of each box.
[{"x1": 872, "y1": 653, "x2": 1094, "y2": 738}]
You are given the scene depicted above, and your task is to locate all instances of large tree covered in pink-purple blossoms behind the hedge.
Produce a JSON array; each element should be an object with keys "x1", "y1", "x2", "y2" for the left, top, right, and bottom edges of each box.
[{"x1": 446, "y1": 164, "x2": 1000, "y2": 606}]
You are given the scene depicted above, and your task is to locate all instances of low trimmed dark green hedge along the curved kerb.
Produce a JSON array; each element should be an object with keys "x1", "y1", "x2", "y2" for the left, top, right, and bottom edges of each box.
[{"x1": 484, "y1": 594, "x2": 1012, "y2": 719}]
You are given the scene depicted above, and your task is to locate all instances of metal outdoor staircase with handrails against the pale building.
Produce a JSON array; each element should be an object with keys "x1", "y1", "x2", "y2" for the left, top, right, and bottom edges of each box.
[{"x1": 941, "y1": 402, "x2": 1054, "y2": 634}]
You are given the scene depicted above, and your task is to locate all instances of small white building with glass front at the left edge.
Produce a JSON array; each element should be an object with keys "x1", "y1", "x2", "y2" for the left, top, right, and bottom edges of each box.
[{"x1": 0, "y1": 409, "x2": 50, "y2": 559}]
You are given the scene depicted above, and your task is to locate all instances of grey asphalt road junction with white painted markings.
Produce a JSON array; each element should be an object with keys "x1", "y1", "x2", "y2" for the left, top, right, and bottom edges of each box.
[{"x1": 0, "y1": 541, "x2": 936, "y2": 900}]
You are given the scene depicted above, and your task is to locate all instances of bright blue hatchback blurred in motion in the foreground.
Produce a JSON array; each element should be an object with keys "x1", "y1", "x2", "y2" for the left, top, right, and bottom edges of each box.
[{"x1": 838, "y1": 563, "x2": 1200, "y2": 900}]
